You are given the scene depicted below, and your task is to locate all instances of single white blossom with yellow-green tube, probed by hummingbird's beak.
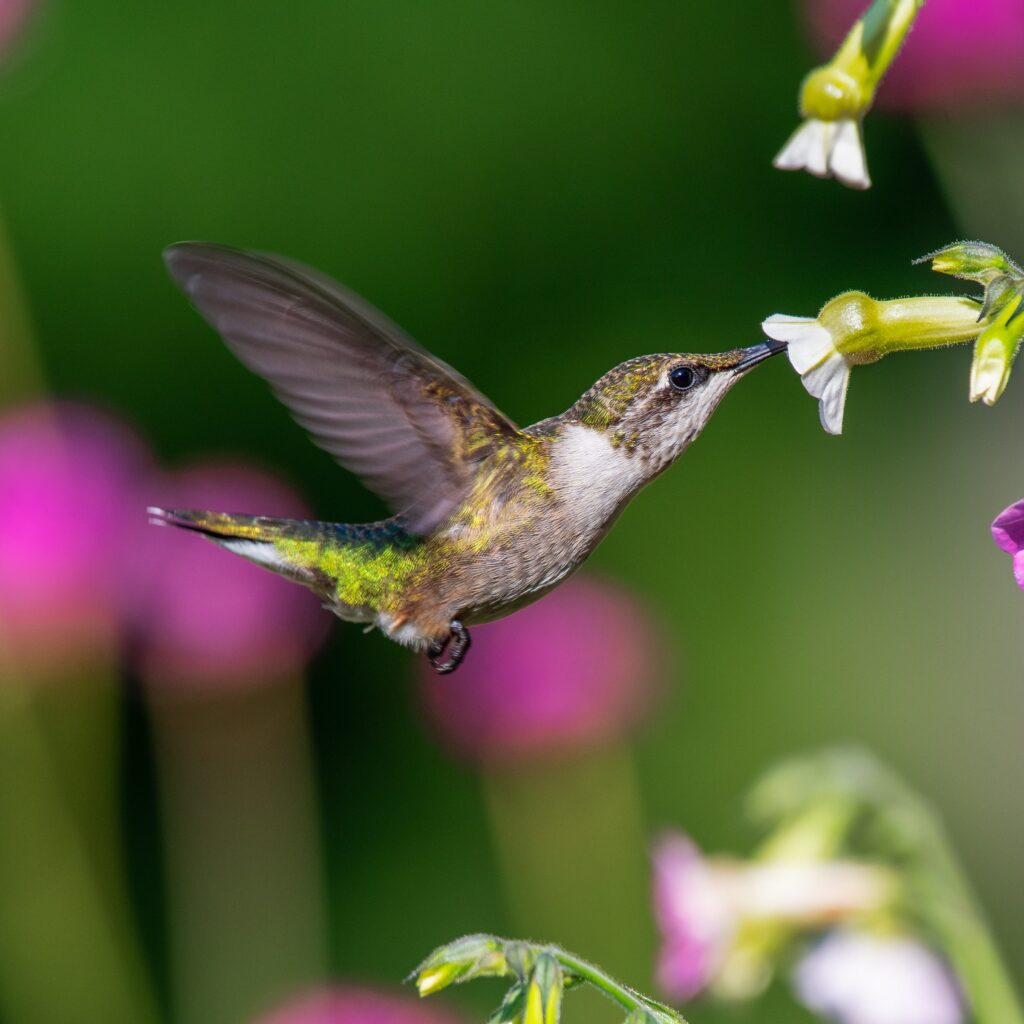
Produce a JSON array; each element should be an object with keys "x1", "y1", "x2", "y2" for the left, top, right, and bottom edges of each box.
[{"x1": 761, "y1": 292, "x2": 984, "y2": 434}]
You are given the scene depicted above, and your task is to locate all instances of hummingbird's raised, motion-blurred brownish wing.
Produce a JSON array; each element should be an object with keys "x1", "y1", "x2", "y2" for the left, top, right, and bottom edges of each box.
[{"x1": 165, "y1": 242, "x2": 517, "y2": 534}]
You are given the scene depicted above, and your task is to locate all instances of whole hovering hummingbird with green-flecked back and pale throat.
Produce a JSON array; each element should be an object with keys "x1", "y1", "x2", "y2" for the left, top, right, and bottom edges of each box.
[{"x1": 148, "y1": 242, "x2": 785, "y2": 675}]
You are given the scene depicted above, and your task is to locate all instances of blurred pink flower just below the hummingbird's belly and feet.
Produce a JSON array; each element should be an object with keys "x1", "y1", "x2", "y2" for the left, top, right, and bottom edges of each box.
[{"x1": 421, "y1": 578, "x2": 659, "y2": 763}]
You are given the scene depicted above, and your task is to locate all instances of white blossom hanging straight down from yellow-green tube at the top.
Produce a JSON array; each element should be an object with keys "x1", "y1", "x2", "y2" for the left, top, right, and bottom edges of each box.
[{"x1": 774, "y1": 0, "x2": 924, "y2": 188}]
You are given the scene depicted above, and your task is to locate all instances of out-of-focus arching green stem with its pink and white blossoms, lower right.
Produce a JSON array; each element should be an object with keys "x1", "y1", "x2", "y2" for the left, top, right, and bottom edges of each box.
[{"x1": 653, "y1": 751, "x2": 983, "y2": 1024}]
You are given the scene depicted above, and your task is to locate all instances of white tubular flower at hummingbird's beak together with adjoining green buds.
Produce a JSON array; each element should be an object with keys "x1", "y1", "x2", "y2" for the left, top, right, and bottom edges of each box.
[{"x1": 761, "y1": 242, "x2": 1024, "y2": 434}]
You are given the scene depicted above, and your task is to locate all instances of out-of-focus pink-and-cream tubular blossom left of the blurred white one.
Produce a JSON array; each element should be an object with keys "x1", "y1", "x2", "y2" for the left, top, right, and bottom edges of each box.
[{"x1": 653, "y1": 834, "x2": 894, "y2": 1000}]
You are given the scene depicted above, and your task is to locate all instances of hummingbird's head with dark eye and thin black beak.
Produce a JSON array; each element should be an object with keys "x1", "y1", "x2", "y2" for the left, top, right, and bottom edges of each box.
[{"x1": 567, "y1": 340, "x2": 785, "y2": 473}]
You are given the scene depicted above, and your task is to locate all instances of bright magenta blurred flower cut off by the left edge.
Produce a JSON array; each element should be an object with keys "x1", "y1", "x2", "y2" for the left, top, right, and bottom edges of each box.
[{"x1": 0, "y1": 404, "x2": 148, "y2": 671}]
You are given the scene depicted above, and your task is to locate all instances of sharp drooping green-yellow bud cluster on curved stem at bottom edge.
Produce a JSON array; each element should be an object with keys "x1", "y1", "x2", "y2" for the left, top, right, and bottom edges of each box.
[{"x1": 411, "y1": 935, "x2": 685, "y2": 1024}]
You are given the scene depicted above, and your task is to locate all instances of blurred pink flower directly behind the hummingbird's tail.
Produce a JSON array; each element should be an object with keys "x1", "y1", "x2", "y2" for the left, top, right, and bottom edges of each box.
[{"x1": 132, "y1": 462, "x2": 330, "y2": 688}]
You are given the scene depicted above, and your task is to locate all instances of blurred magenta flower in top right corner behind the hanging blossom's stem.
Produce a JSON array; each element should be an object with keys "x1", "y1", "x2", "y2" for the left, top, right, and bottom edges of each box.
[{"x1": 803, "y1": 0, "x2": 1024, "y2": 111}]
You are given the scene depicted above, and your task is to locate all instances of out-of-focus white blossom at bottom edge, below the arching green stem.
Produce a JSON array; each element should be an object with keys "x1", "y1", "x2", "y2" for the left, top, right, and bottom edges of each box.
[{"x1": 794, "y1": 930, "x2": 965, "y2": 1024}]
